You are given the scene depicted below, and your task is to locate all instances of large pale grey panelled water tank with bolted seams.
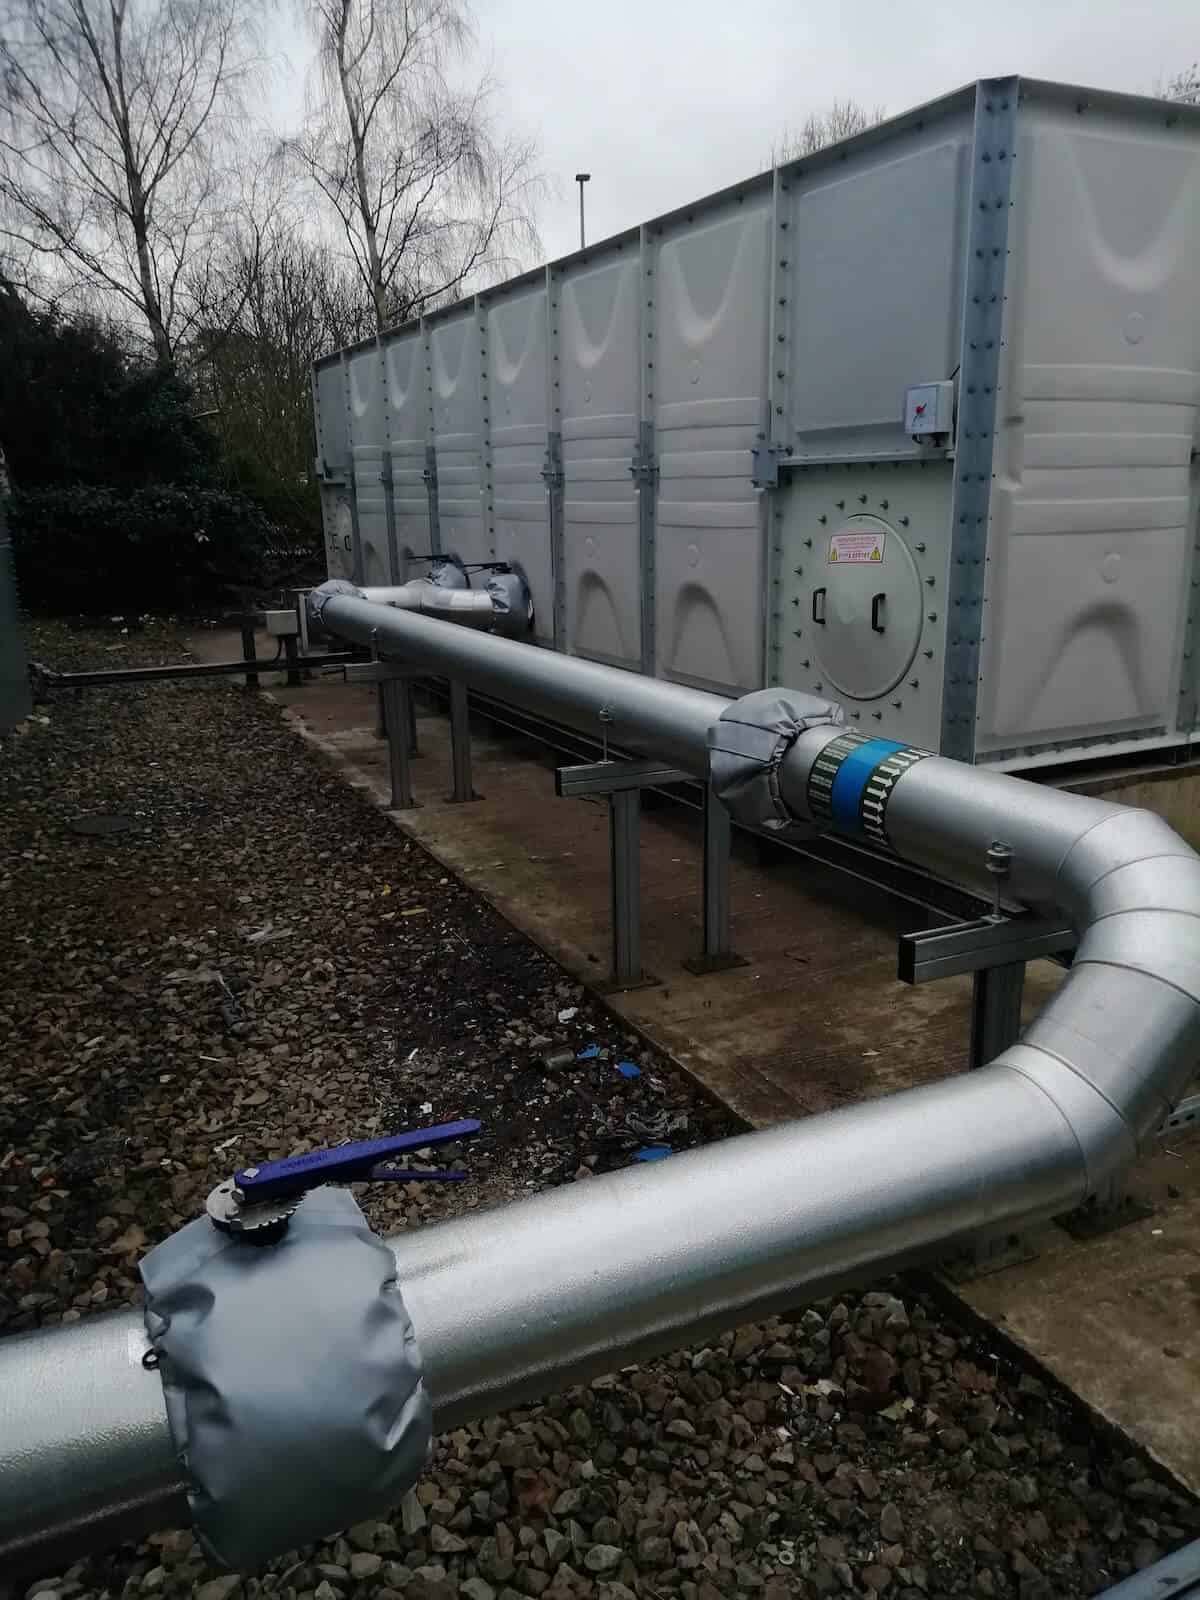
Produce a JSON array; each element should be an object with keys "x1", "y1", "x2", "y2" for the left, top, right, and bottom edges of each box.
[{"x1": 315, "y1": 78, "x2": 1200, "y2": 768}]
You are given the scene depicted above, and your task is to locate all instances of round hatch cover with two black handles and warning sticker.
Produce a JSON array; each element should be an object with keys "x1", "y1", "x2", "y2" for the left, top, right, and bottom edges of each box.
[{"x1": 811, "y1": 517, "x2": 922, "y2": 699}]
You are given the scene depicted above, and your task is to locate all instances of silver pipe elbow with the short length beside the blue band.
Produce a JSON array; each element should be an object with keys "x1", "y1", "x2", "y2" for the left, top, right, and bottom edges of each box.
[{"x1": 779, "y1": 728, "x2": 1200, "y2": 1171}]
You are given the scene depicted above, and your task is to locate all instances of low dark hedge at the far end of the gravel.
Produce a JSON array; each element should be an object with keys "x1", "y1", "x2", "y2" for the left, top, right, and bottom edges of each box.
[{"x1": 8, "y1": 483, "x2": 320, "y2": 616}]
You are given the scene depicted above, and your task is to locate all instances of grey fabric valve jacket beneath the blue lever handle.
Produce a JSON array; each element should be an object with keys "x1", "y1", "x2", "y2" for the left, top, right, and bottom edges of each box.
[{"x1": 141, "y1": 1189, "x2": 432, "y2": 1571}]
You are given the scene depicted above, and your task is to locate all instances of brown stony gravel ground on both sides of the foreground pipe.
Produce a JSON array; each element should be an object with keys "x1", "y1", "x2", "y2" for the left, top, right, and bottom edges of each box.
[{"x1": 0, "y1": 626, "x2": 1200, "y2": 1600}]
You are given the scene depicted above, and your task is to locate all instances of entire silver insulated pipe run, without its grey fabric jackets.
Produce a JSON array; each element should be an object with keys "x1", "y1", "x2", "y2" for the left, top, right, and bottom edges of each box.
[{"x1": 0, "y1": 594, "x2": 1200, "y2": 1558}]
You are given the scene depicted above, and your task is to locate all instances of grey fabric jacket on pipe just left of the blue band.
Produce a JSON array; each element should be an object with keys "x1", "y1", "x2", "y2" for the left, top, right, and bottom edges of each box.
[{"x1": 709, "y1": 690, "x2": 846, "y2": 838}]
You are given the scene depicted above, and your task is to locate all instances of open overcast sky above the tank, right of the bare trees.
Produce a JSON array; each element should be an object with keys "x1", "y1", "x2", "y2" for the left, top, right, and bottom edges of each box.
[{"x1": 272, "y1": 0, "x2": 1200, "y2": 258}]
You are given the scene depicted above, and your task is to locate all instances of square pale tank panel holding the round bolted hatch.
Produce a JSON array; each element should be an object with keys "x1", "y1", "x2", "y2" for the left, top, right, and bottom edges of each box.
[{"x1": 773, "y1": 461, "x2": 952, "y2": 749}]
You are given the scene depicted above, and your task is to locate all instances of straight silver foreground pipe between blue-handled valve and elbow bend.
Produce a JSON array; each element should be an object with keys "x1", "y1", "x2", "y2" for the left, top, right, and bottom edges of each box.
[{"x1": 390, "y1": 1067, "x2": 1086, "y2": 1429}]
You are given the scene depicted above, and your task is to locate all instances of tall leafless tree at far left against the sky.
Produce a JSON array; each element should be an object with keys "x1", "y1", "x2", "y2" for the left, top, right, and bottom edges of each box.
[{"x1": 0, "y1": 0, "x2": 262, "y2": 366}]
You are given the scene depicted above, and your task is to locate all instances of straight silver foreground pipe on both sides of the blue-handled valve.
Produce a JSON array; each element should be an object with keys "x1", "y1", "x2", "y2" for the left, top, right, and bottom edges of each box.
[{"x1": 0, "y1": 1069, "x2": 1085, "y2": 1555}]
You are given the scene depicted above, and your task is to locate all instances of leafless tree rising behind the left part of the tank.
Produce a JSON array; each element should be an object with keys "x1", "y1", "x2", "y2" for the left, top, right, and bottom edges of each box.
[{"x1": 291, "y1": 0, "x2": 541, "y2": 328}]
